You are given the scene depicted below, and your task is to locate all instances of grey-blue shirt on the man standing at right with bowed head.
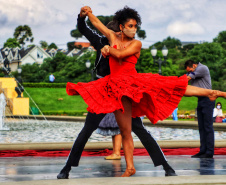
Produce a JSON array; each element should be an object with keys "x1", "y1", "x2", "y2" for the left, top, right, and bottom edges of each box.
[{"x1": 187, "y1": 62, "x2": 212, "y2": 89}]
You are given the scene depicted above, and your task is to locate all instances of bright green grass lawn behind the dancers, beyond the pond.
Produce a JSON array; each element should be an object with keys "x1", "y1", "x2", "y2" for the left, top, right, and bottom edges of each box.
[{"x1": 24, "y1": 88, "x2": 226, "y2": 111}]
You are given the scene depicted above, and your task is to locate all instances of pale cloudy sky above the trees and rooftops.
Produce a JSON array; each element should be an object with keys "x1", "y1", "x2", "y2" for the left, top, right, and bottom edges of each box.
[{"x1": 0, "y1": 0, "x2": 226, "y2": 49}]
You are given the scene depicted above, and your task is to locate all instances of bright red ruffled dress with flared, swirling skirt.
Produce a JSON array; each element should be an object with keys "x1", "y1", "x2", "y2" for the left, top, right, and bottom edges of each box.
[{"x1": 66, "y1": 46, "x2": 188, "y2": 124}]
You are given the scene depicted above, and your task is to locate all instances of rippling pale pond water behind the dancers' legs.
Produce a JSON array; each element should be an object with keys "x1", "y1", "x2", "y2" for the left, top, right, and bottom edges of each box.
[{"x1": 0, "y1": 120, "x2": 226, "y2": 143}]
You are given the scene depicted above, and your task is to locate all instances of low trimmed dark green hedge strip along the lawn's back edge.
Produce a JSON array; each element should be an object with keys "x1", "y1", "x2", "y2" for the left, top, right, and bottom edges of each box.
[{"x1": 23, "y1": 82, "x2": 67, "y2": 88}]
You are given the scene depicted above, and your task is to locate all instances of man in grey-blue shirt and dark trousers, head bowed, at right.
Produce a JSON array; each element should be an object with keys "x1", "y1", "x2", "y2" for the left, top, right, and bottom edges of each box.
[{"x1": 184, "y1": 60, "x2": 215, "y2": 158}]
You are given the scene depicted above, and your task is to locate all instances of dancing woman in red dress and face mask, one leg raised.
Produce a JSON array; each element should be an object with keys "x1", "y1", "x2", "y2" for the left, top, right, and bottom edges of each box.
[{"x1": 66, "y1": 6, "x2": 226, "y2": 177}]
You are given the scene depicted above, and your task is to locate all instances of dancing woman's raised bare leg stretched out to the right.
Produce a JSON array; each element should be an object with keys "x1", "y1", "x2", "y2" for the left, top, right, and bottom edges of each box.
[{"x1": 184, "y1": 85, "x2": 226, "y2": 101}]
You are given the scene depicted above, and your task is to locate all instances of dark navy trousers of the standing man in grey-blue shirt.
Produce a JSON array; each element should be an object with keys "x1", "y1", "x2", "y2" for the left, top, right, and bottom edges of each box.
[{"x1": 197, "y1": 97, "x2": 215, "y2": 155}]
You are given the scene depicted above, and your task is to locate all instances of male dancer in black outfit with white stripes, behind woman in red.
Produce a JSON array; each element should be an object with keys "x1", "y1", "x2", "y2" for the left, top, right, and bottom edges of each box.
[{"x1": 57, "y1": 11, "x2": 177, "y2": 179}]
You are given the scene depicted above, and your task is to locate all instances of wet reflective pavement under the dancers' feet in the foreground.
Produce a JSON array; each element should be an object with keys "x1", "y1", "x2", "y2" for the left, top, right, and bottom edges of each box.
[{"x1": 0, "y1": 155, "x2": 226, "y2": 185}]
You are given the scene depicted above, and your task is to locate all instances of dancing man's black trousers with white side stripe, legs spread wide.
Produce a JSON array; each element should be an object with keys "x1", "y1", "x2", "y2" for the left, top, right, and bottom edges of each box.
[{"x1": 66, "y1": 112, "x2": 166, "y2": 166}]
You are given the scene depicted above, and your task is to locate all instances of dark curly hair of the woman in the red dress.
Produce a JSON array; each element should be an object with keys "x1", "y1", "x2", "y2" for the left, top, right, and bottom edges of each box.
[{"x1": 113, "y1": 6, "x2": 141, "y2": 26}]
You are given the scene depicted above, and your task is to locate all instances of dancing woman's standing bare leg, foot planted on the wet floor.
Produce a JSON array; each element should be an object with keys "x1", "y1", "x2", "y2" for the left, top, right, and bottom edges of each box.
[{"x1": 114, "y1": 96, "x2": 136, "y2": 177}]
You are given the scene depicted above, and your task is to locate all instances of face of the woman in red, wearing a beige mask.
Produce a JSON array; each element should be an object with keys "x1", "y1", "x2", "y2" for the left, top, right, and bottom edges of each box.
[{"x1": 120, "y1": 19, "x2": 137, "y2": 38}]
